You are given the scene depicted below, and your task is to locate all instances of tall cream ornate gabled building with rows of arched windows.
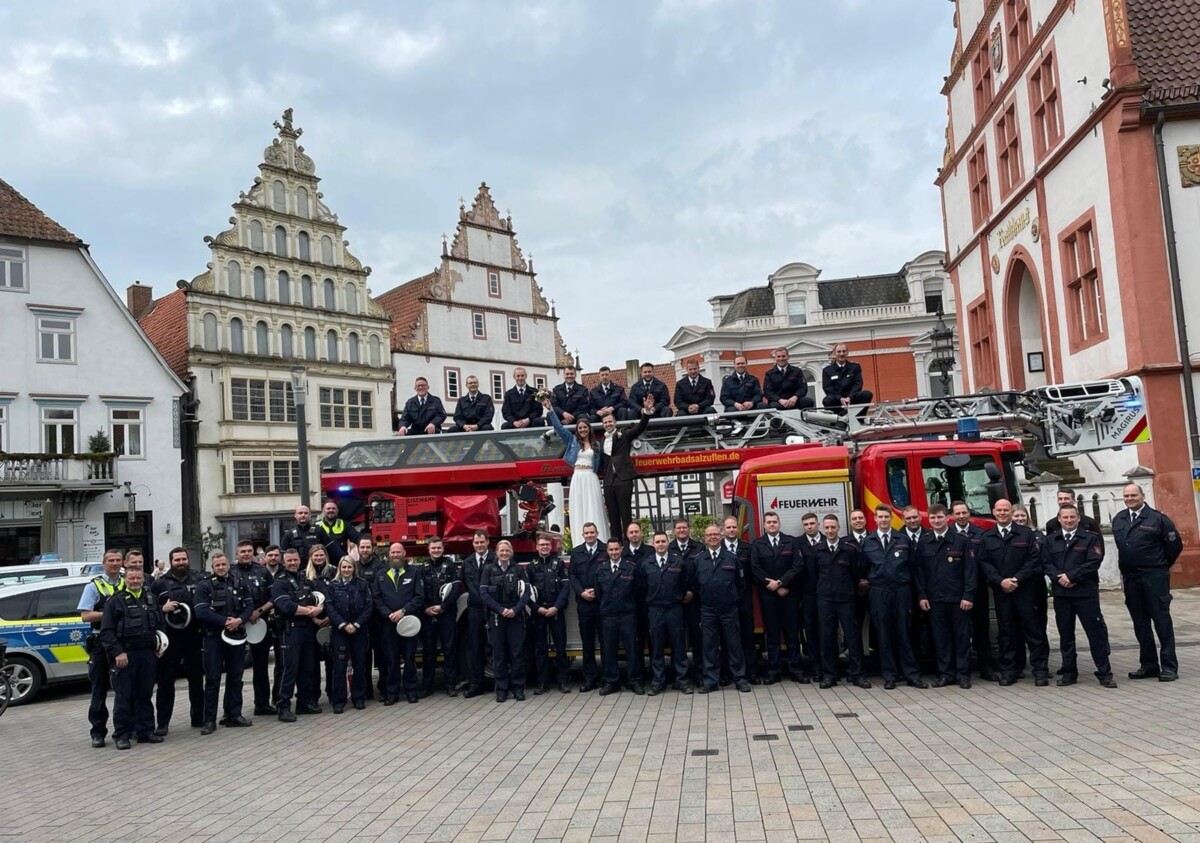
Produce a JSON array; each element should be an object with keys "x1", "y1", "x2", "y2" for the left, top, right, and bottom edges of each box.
[{"x1": 130, "y1": 108, "x2": 394, "y2": 550}]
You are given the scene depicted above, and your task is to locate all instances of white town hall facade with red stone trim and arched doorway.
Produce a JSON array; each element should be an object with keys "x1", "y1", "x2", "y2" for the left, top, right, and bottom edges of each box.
[{"x1": 937, "y1": 0, "x2": 1200, "y2": 584}]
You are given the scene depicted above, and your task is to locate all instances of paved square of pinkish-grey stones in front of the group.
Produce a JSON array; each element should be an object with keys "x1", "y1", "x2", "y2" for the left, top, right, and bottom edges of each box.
[{"x1": 0, "y1": 591, "x2": 1200, "y2": 843}]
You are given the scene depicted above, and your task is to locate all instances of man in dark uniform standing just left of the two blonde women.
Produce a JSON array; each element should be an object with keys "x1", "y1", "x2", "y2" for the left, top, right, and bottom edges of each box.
[{"x1": 271, "y1": 548, "x2": 320, "y2": 723}]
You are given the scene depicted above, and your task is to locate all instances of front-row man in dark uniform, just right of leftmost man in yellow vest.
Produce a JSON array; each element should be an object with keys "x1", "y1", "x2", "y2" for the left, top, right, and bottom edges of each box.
[{"x1": 100, "y1": 568, "x2": 164, "y2": 749}]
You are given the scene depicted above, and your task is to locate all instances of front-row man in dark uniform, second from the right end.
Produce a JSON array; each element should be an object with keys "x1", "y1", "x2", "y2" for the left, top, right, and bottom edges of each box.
[{"x1": 1042, "y1": 503, "x2": 1117, "y2": 688}]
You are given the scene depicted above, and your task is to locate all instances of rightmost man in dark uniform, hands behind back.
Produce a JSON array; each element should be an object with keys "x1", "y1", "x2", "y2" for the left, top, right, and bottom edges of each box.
[{"x1": 1112, "y1": 483, "x2": 1183, "y2": 682}]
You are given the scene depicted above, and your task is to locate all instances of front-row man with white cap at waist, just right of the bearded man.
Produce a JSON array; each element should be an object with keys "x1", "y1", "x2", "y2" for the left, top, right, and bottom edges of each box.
[{"x1": 196, "y1": 551, "x2": 254, "y2": 735}]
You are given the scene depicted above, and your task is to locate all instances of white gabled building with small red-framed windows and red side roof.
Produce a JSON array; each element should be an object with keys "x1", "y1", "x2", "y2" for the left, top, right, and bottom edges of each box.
[{"x1": 376, "y1": 184, "x2": 574, "y2": 429}]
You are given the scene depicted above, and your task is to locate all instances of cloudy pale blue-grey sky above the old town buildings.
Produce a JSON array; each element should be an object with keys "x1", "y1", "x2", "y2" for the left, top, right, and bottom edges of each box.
[{"x1": 0, "y1": 0, "x2": 953, "y2": 369}]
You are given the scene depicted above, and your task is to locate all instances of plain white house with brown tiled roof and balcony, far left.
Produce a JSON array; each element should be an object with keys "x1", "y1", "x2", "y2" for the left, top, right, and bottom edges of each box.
[{"x1": 0, "y1": 180, "x2": 186, "y2": 564}]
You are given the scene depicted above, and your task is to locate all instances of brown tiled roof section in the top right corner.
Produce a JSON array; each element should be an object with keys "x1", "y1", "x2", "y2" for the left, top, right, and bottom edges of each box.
[{"x1": 1126, "y1": 0, "x2": 1200, "y2": 106}]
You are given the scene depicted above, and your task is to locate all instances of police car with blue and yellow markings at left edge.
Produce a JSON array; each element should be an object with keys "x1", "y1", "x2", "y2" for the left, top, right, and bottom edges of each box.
[{"x1": 0, "y1": 576, "x2": 91, "y2": 705}]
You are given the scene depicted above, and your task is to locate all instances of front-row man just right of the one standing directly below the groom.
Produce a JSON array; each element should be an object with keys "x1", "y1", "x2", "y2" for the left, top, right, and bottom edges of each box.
[{"x1": 638, "y1": 532, "x2": 694, "y2": 696}]
